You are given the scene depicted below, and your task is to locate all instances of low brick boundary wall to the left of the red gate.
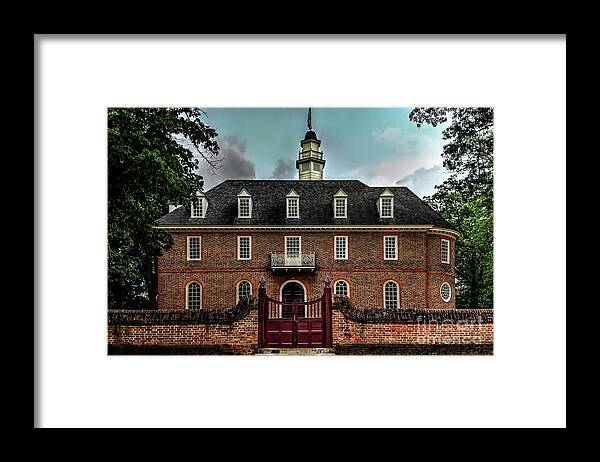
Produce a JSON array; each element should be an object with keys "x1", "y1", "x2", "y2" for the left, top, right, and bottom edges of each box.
[{"x1": 108, "y1": 310, "x2": 258, "y2": 354}]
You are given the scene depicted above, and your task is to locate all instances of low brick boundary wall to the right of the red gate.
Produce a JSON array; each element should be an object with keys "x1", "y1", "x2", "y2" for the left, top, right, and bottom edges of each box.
[{"x1": 332, "y1": 310, "x2": 494, "y2": 347}]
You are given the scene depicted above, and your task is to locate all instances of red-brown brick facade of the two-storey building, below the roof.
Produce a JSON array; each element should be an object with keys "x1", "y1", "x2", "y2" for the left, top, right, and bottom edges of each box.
[{"x1": 158, "y1": 232, "x2": 455, "y2": 309}]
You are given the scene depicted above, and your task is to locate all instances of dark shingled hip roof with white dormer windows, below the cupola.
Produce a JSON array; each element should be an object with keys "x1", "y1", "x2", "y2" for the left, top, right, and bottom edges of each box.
[{"x1": 157, "y1": 180, "x2": 454, "y2": 229}]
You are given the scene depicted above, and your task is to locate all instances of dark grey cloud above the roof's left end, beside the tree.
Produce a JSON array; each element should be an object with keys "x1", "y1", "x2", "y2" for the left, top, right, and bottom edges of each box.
[{"x1": 200, "y1": 135, "x2": 256, "y2": 190}]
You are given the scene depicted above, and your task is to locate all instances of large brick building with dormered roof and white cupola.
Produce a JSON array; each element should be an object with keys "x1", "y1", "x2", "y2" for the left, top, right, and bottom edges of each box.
[{"x1": 157, "y1": 112, "x2": 457, "y2": 346}]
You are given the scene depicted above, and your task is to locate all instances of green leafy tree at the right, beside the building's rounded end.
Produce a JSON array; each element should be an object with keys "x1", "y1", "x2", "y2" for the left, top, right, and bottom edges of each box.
[{"x1": 409, "y1": 108, "x2": 494, "y2": 308}]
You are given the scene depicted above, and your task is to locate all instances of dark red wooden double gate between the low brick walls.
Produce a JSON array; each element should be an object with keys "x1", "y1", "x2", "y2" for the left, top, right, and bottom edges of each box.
[{"x1": 258, "y1": 277, "x2": 331, "y2": 348}]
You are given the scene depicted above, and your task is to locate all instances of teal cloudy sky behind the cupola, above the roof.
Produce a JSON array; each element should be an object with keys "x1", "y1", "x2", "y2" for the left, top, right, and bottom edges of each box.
[{"x1": 199, "y1": 107, "x2": 448, "y2": 197}]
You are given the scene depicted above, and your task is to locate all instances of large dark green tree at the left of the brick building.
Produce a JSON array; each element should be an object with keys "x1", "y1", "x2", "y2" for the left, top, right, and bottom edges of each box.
[{"x1": 108, "y1": 108, "x2": 222, "y2": 308}]
